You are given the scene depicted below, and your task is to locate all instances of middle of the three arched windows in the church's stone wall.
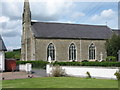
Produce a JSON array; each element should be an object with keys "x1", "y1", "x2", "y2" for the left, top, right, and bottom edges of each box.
[{"x1": 69, "y1": 43, "x2": 76, "y2": 61}]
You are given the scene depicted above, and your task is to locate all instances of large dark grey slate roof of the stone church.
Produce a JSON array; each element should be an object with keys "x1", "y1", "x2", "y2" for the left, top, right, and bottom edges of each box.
[{"x1": 31, "y1": 22, "x2": 112, "y2": 39}]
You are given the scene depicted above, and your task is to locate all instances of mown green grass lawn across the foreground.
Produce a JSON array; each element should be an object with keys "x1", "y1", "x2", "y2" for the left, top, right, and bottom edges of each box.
[{"x1": 2, "y1": 77, "x2": 118, "y2": 88}]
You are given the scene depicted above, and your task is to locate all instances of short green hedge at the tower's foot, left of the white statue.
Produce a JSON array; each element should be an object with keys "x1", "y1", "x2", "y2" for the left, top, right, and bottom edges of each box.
[{"x1": 17, "y1": 61, "x2": 48, "y2": 69}]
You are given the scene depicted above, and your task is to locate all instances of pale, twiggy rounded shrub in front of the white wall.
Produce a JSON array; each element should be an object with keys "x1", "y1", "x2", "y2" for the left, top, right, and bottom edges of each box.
[{"x1": 52, "y1": 65, "x2": 65, "y2": 77}]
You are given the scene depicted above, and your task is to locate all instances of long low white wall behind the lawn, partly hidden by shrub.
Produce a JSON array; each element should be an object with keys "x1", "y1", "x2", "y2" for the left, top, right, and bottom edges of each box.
[{"x1": 46, "y1": 65, "x2": 119, "y2": 79}]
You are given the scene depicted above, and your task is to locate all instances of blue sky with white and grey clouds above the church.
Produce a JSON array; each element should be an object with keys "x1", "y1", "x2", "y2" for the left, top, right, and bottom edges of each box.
[{"x1": 0, "y1": 0, "x2": 118, "y2": 50}]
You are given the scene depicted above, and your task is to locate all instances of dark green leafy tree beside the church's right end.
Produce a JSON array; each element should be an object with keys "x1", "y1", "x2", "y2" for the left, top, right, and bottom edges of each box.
[{"x1": 105, "y1": 34, "x2": 120, "y2": 58}]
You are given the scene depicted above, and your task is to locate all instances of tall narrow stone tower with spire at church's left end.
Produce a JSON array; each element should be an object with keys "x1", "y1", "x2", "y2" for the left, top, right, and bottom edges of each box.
[{"x1": 21, "y1": 0, "x2": 31, "y2": 61}]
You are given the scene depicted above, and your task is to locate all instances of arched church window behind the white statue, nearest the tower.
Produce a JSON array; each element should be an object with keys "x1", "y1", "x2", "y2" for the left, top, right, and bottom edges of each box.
[{"x1": 47, "y1": 43, "x2": 55, "y2": 60}]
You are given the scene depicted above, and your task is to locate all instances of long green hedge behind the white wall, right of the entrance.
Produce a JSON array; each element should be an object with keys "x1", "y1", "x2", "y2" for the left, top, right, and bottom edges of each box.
[{"x1": 53, "y1": 62, "x2": 120, "y2": 67}]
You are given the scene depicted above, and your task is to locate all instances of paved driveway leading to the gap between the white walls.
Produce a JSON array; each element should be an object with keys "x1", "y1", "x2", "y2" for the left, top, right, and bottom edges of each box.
[{"x1": 0, "y1": 69, "x2": 47, "y2": 80}]
